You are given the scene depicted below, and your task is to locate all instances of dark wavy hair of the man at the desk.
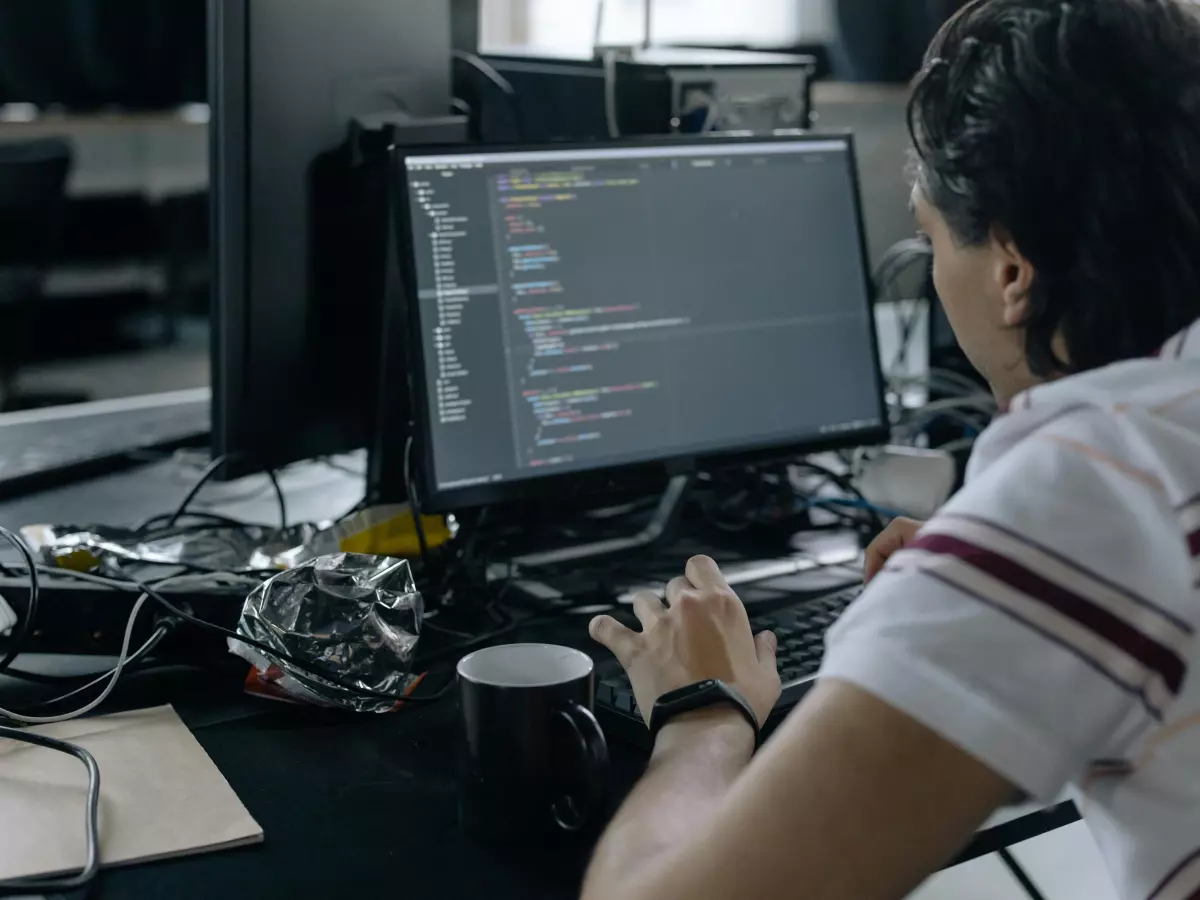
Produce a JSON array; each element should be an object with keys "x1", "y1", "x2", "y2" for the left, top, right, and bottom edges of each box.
[{"x1": 908, "y1": 0, "x2": 1200, "y2": 377}]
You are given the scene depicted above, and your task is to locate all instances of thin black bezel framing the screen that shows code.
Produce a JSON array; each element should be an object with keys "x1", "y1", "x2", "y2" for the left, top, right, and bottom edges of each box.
[{"x1": 380, "y1": 131, "x2": 889, "y2": 512}]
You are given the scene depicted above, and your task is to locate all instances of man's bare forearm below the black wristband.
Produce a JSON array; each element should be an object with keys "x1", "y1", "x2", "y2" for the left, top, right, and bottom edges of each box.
[{"x1": 583, "y1": 709, "x2": 754, "y2": 900}]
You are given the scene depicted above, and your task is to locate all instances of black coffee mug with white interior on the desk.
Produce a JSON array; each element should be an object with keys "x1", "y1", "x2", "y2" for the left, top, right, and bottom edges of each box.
[{"x1": 458, "y1": 643, "x2": 608, "y2": 841}]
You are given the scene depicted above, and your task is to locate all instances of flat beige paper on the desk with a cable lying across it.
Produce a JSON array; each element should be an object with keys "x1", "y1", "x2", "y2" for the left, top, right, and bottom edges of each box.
[{"x1": 0, "y1": 707, "x2": 263, "y2": 880}]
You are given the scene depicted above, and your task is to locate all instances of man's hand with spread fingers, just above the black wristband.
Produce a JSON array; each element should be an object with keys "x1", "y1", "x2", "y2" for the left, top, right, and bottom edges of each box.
[{"x1": 590, "y1": 557, "x2": 780, "y2": 724}]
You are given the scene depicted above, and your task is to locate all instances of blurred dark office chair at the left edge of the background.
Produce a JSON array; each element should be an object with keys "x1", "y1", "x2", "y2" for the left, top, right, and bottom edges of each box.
[{"x1": 0, "y1": 138, "x2": 88, "y2": 410}]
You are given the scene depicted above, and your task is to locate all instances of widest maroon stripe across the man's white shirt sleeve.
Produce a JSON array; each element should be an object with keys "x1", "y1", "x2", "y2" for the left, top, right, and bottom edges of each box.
[{"x1": 908, "y1": 534, "x2": 1187, "y2": 694}]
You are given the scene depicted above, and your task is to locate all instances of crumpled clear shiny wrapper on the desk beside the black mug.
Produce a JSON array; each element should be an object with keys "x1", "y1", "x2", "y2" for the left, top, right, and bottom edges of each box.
[{"x1": 229, "y1": 553, "x2": 425, "y2": 713}]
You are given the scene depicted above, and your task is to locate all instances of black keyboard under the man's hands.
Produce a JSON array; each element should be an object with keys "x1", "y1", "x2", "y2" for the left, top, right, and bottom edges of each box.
[{"x1": 596, "y1": 584, "x2": 863, "y2": 750}]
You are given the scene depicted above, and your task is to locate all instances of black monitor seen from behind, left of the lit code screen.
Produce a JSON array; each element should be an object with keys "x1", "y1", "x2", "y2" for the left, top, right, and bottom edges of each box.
[{"x1": 209, "y1": 0, "x2": 451, "y2": 475}]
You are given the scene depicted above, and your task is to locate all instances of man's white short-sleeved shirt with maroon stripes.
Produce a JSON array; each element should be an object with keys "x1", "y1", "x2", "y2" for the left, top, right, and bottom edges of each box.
[{"x1": 822, "y1": 323, "x2": 1200, "y2": 900}]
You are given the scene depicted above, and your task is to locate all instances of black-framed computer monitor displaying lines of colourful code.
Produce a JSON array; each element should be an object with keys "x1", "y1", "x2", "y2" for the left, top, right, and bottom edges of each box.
[{"x1": 383, "y1": 134, "x2": 887, "y2": 511}]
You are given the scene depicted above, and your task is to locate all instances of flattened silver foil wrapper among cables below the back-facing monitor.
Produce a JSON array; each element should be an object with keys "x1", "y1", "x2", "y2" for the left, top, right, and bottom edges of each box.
[{"x1": 22, "y1": 524, "x2": 318, "y2": 571}]
